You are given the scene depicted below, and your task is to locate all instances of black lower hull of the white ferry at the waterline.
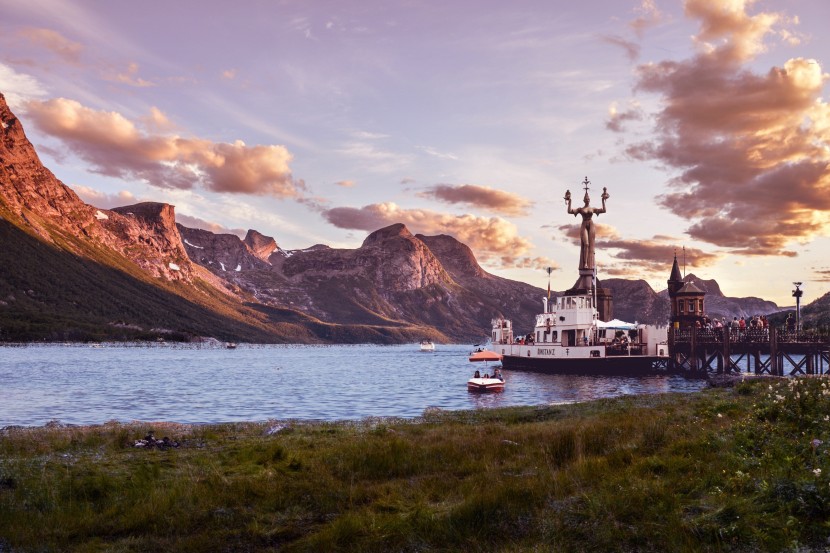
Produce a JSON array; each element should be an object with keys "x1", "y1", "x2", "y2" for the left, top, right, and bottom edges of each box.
[{"x1": 502, "y1": 355, "x2": 666, "y2": 376}]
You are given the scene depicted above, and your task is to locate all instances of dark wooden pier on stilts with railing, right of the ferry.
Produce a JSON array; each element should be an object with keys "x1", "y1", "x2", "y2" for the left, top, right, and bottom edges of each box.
[{"x1": 667, "y1": 327, "x2": 830, "y2": 377}]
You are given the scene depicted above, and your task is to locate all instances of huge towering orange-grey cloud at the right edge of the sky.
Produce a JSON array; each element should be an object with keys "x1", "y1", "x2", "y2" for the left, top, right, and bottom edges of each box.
[{"x1": 627, "y1": 0, "x2": 830, "y2": 256}]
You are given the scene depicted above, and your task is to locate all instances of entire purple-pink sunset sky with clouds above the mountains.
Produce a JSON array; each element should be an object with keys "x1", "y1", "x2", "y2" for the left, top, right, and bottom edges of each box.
[{"x1": 0, "y1": 0, "x2": 830, "y2": 306}]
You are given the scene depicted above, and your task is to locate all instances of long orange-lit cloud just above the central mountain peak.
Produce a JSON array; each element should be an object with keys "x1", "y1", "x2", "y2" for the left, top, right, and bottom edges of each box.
[{"x1": 322, "y1": 202, "x2": 533, "y2": 266}]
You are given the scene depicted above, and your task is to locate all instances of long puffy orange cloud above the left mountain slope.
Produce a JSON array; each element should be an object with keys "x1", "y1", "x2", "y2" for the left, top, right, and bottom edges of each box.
[{"x1": 26, "y1": 98, "x2": 305, "y2": 199}]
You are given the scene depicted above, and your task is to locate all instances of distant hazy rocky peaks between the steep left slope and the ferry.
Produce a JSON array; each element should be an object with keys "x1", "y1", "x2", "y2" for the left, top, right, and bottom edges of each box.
[{"x1": 178, "y1": 220, "x2": 543, "y2": 341}]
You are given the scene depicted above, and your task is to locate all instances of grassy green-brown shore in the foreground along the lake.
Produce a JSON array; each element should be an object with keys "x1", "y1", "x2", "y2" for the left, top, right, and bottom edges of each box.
[{"x1": 0, "y1": 378, "x2": 830, "y2": 552}]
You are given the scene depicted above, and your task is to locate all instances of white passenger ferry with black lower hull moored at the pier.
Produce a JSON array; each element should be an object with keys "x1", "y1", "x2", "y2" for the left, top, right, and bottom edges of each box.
[{"x1": 490, "y1": 294, "x2": 669, "y2": 376}]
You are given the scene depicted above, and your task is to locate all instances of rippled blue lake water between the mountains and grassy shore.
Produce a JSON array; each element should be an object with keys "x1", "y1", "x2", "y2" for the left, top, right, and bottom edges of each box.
[{"x1": 0, "y1": 344, "x2": 705, "y2": 427}]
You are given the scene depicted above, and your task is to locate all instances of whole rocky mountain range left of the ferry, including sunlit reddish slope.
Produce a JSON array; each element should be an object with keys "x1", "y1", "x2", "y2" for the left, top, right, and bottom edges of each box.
[{"x1": 0, "y1": 95, "x2": 542, "y2": 343}]
